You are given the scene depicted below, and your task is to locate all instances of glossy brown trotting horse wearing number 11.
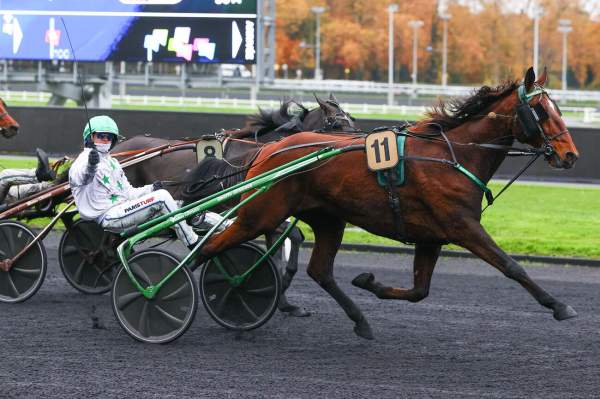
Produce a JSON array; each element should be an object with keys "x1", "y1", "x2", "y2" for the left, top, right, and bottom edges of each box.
[{"x1": 201, "y1": 68, "x2": 578, "y2": 339}]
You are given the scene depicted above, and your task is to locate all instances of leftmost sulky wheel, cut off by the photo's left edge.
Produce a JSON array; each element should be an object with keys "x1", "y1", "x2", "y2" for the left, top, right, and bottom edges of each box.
[{"x1": 0, "y1": 220, "x2": 47, "y2": 303}]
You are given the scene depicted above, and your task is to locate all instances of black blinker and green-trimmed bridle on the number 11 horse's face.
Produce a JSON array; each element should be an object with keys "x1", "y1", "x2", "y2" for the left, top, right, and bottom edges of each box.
[{"x1": 515, "y1": 85, "x2": 568, "y2": 157}]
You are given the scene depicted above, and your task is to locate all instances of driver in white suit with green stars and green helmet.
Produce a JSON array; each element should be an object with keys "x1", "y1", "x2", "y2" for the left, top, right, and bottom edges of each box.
[{"x1": 69, "y1": 115, "x2": 198, "y2": 248}]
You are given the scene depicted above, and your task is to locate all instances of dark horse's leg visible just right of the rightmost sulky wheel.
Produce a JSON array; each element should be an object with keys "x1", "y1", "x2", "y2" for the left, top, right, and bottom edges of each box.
[{"x1": 265, "y1": 227, "x2": 310, "y2": 317}]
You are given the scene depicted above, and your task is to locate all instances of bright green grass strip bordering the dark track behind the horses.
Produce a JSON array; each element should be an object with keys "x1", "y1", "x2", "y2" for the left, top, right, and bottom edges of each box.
[{"x1": 0, "y1": 162, "x2": 600, "y2": 258}]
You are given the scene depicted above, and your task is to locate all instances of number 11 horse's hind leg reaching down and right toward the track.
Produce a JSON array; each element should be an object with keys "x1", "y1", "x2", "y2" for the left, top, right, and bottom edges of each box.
[{"x1": 303, "y1": 214, "x2": 373, "y2": 339}]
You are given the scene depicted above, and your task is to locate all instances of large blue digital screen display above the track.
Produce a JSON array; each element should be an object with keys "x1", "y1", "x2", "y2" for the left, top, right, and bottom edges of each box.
[{"x1": 0, "y1": 0, "x2": 257, "y2": 64}]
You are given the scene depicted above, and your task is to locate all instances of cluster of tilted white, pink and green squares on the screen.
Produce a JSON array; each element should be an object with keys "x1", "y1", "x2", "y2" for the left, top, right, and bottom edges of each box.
[{"x1": 144, "y1": 26, "x2": 216, "y2": 62}]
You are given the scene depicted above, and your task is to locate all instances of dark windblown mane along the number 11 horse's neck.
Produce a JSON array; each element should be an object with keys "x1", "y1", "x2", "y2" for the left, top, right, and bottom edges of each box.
[{"x1": 415, "y1": 81, "x2": 518, "y2": 130}]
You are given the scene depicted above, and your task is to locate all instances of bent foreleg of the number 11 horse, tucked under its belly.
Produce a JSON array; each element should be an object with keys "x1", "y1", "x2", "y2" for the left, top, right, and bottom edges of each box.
[{"x1": 352, "y1": 244, "x2": 442, "y2": 302}]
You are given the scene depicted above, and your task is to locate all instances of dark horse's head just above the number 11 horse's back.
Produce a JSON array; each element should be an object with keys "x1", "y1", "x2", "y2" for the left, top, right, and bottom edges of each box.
[{"x1": 303, "y1": 94, "x2": 356, "y2": 131}]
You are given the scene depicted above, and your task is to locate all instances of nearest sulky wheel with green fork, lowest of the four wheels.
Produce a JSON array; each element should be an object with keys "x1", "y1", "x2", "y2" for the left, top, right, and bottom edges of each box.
[{"x1": 111, "y1": 249, "x2": 198, "y2": 344}]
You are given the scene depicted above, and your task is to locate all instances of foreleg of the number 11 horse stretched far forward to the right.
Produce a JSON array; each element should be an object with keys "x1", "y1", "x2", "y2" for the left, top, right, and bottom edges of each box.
[{"x1": 454, "y1": 221, "x2": 577, "y2": 320}]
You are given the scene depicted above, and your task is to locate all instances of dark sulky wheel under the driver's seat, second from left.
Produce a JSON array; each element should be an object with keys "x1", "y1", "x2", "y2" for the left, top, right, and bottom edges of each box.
[{"x1": 58, "y1": 219, "x2": 119, "y2": 294}]
